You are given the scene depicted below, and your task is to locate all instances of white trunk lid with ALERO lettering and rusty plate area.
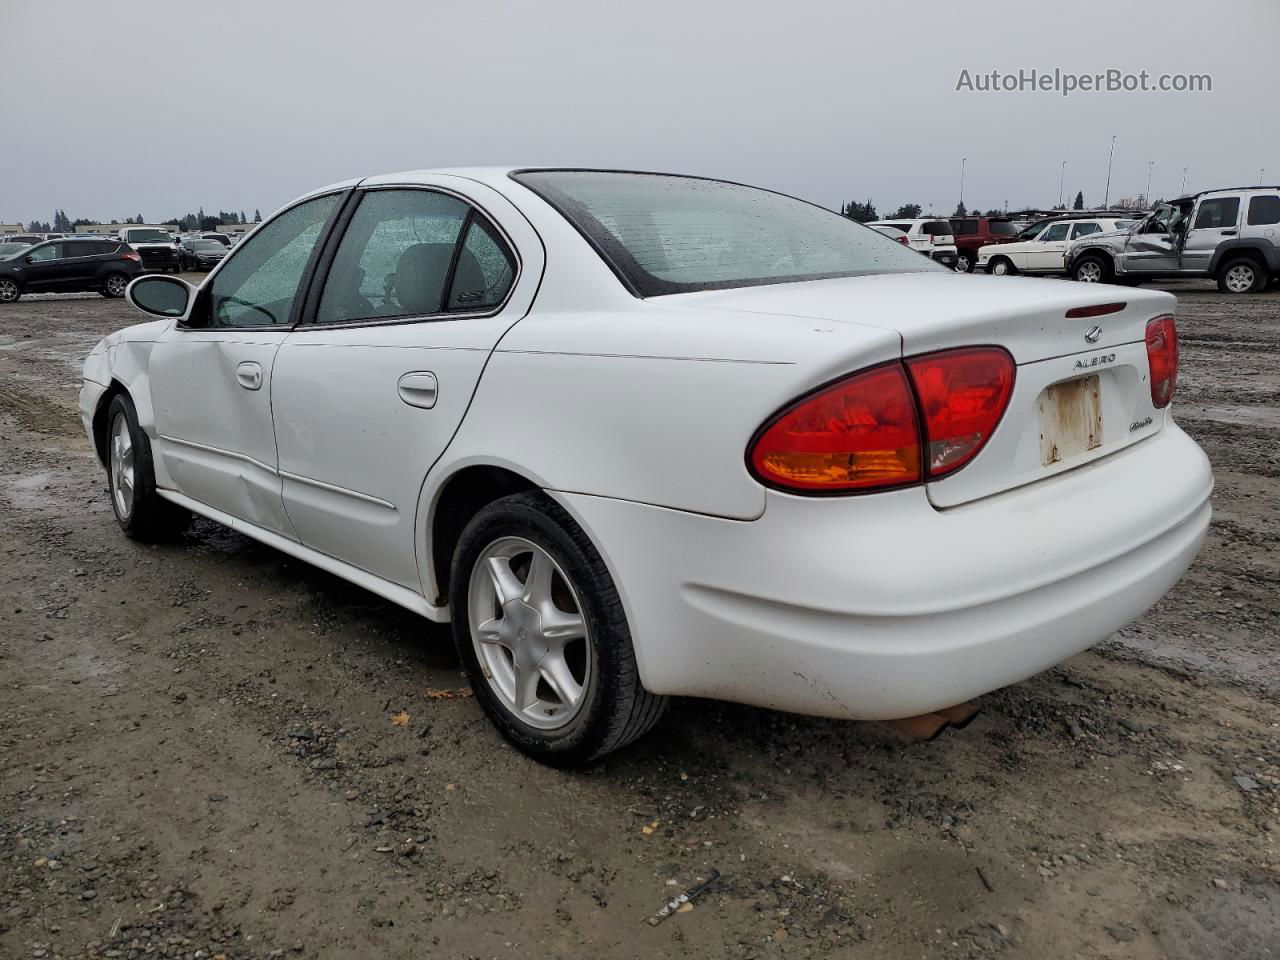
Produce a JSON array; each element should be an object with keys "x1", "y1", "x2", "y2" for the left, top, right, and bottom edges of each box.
[{"x1": 687, "y1": 273, "x2": 1176, "y2": 508}]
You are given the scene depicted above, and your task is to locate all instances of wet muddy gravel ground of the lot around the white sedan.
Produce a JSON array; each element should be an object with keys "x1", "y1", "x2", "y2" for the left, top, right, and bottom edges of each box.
[{"x1": 0, "y1": 284, "x2": 1280, "y2": 960}]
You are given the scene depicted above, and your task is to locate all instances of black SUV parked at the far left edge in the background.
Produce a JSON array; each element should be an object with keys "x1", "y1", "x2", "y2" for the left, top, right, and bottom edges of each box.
[{"x1": 0, "y1": 239, "x2": 142, "y2": 303}]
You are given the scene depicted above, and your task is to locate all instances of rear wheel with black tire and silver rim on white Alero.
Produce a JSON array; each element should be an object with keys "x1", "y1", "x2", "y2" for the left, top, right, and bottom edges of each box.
[{"x1": 449, "y1": 493, "x2": 666, "y2": 767}]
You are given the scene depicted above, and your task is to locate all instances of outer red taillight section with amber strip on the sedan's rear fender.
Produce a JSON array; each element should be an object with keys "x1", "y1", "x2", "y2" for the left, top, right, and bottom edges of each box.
[{"x1": 750, "y1": 362, "x2": 922, "y2": 493}]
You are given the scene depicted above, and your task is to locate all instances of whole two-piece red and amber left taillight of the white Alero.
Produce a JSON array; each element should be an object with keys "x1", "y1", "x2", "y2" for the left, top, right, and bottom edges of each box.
[{"x1": 748, "y1": 347, "x2": 1014, "y2": 494}]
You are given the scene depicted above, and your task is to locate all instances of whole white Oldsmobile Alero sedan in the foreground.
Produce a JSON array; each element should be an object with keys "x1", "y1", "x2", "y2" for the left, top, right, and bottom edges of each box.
[{"x1": 81, "y1": 169, "x2": 1212, "y2": 765}]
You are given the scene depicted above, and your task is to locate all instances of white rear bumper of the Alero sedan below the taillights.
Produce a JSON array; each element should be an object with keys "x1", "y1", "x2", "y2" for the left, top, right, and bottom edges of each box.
[{"x1": 554, "y1": 421, "x2": 1213, "y2": 719}]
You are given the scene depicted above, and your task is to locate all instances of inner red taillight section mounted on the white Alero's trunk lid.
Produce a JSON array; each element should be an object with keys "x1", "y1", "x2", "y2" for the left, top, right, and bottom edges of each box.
[{"x1": 906, "y1": 347, "x2": 1014, "y2": 479}]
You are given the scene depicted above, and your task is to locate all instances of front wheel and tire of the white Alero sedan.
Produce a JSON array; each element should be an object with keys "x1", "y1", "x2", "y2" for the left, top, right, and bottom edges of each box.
[{"x1": 104, "y1": 393, "x2": 191, "y2": 541}]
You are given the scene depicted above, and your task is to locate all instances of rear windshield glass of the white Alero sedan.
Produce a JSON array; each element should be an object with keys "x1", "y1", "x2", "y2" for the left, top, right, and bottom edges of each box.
[{"x1": 513, "y1": 170, "x2": 943, "y2": 297}]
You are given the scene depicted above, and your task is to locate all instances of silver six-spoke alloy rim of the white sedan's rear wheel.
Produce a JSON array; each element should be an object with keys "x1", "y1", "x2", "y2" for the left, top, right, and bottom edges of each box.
[{"x1": 467, "y1": 536, "x2": 594, "y2": 731}]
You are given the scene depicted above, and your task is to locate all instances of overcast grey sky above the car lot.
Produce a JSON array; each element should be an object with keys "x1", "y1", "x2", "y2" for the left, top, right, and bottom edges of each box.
[{"x1": 0, "y1": 0, "x2": 1280, "y2": 223}]
